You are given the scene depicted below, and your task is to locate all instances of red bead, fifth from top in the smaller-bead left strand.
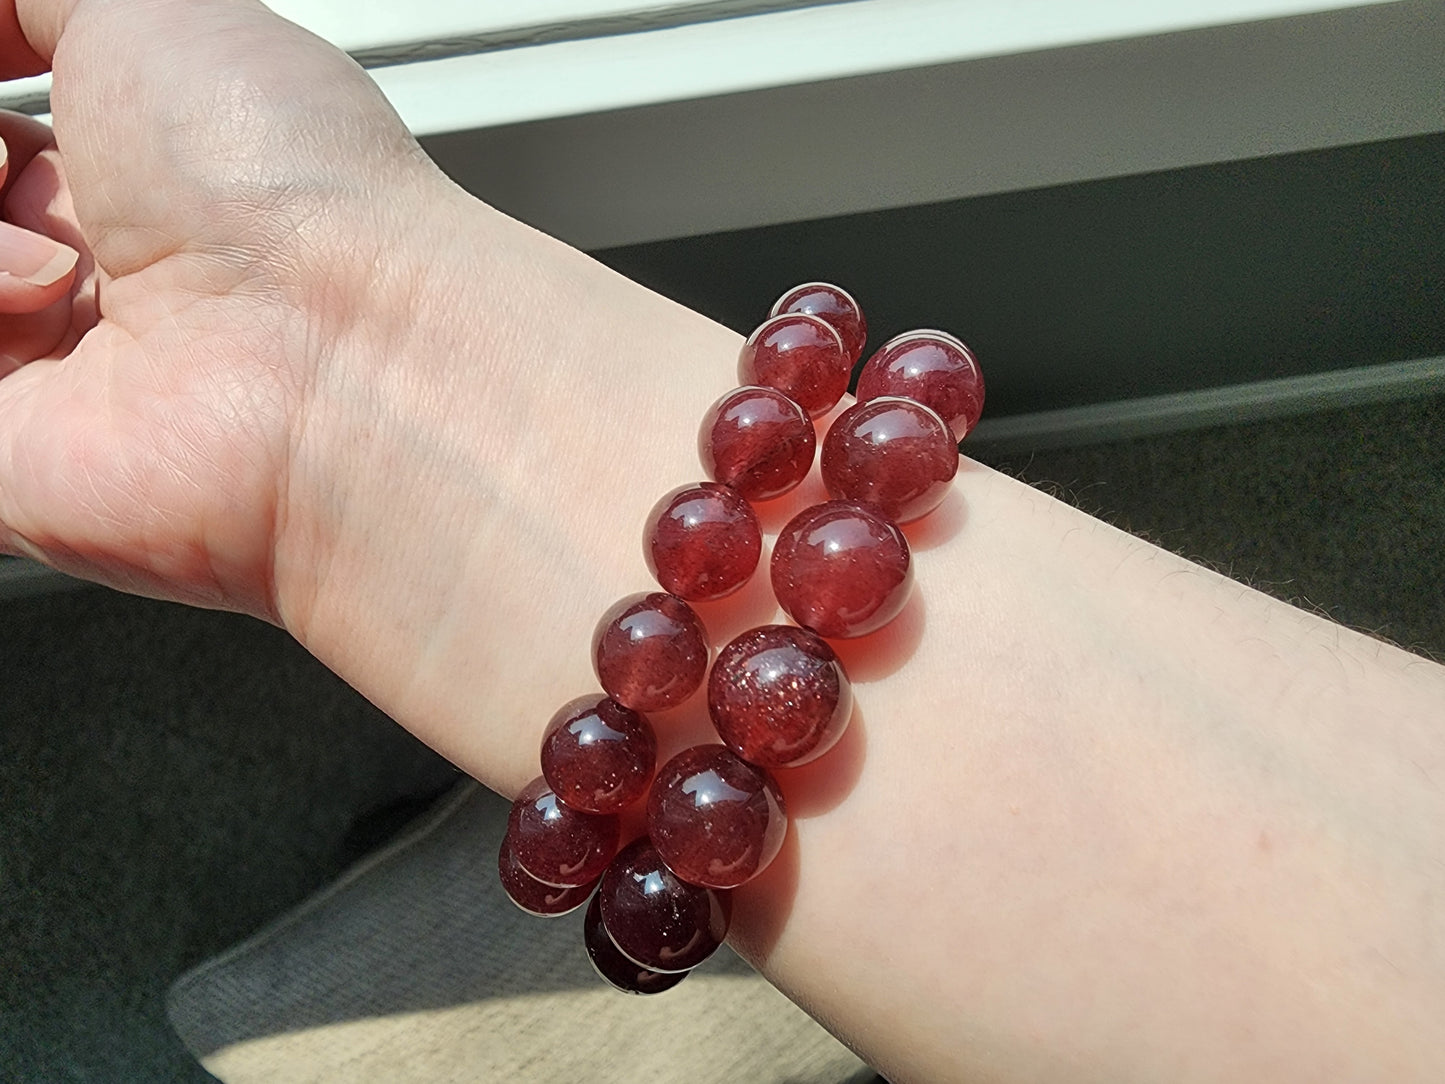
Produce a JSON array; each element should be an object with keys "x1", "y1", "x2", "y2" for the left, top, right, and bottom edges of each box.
[{"x1": 592, "y1": 591, "x2": 708, "y2": 711}]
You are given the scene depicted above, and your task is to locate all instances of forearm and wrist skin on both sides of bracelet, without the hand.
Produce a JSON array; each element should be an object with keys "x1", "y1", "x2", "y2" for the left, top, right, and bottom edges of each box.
[{"x1": 277, "y1": 190, "x2": 1445, "y2": 1080}]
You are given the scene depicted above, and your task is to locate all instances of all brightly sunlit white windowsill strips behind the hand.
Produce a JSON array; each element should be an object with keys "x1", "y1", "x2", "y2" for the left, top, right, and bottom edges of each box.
[{"x1": 0, "y1": 0, "x2": 1400, "y2": 127}]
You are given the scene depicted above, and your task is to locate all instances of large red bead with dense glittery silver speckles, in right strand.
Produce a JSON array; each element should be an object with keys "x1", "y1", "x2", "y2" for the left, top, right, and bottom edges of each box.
[{"x1": 708, "y1": 624, "x2": 853, "y2": 768}]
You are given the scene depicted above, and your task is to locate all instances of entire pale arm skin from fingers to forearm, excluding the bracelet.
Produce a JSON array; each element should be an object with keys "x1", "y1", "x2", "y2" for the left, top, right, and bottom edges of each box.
[{"x1": 0, "y1": 0, "x2": 1445, "y2": 1081}]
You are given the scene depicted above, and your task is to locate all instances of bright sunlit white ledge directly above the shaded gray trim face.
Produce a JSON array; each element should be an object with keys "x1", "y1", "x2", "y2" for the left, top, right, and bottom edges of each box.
[{"x1": 373, "y1": 0, "x2": 1404, "y2": 134}]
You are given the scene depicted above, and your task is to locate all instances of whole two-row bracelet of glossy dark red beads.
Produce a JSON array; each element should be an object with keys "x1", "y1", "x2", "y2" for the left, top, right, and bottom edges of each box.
[{"x1": 497, "y1": 282, "x2": 984, "y2": 993}]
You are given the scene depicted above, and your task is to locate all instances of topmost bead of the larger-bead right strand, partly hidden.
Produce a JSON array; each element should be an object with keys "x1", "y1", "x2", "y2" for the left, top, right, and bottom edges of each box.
[{"x1": 858, "y1": 331, "x2": 984, "y2": 442}]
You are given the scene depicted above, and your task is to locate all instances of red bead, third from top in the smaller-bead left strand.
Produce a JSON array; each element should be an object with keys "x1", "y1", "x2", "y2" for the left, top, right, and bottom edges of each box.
[{"x1": 698, "y1": 387, "x2": 818, "y2": 500}]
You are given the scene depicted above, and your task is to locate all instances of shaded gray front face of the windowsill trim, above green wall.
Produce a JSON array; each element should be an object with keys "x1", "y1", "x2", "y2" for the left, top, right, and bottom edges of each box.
[{"x1": 429, "y1": 0, "x2": 1445, "y2": 247}]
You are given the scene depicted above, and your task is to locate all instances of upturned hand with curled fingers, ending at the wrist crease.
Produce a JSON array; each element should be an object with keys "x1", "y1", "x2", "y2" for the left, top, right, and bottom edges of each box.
[{"x1": 0, "y1": 0, "x2": 449, "y2": 619}]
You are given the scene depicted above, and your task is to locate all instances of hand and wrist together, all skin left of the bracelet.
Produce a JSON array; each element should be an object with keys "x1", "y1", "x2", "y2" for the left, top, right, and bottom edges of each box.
[{"x1": 0, "y1": 0, "x2": 737, "y2": 791}]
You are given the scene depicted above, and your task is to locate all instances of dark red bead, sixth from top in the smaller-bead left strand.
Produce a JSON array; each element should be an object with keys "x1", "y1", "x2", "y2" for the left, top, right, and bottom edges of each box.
[{"x1": 542, "y1": 694, "x2": 657, "y2": 814}]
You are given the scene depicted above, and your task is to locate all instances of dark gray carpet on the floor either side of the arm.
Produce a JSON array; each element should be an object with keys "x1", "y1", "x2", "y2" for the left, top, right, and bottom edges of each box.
[{"x1": 0, "y1": 397, "x2": 1445, "y2": 1084}]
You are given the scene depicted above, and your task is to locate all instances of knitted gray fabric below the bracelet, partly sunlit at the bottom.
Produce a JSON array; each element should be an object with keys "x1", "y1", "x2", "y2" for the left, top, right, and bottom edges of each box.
[{"x1": 169, "y1": 783, "x2": 873, "y2": 1084}]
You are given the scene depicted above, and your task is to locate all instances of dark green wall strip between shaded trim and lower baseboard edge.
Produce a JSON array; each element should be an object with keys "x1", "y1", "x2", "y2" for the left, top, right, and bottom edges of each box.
[{"x1": 597, "y1": 134, "x2": 1445, "y2": 416}]
